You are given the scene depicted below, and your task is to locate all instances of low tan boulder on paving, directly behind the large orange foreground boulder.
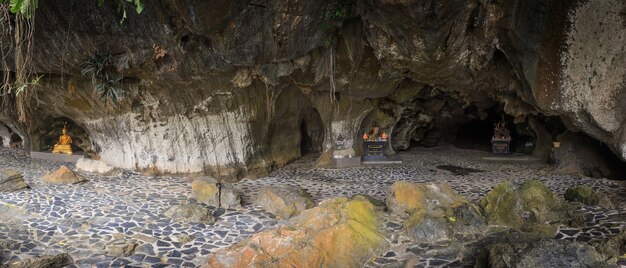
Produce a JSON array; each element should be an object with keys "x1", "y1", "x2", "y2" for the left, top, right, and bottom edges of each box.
[{"x1": 254, "y1": 186, "x2": 315, "y2": 219}]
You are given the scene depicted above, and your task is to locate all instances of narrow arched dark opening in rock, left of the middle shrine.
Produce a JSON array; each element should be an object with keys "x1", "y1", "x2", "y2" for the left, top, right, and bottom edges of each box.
[{"x1": 300, "y1": 108, "x2": 324, "y2": 156}]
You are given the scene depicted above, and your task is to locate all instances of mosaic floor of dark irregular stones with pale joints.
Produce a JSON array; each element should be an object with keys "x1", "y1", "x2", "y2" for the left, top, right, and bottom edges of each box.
[{"x1": 0, "y1": 147, "x2": 626, "y2": 267}]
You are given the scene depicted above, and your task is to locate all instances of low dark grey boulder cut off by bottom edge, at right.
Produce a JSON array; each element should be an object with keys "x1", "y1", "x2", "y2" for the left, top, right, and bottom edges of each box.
[{"x1": 475, "y1": 240, "x2": 608, "y2": 268}]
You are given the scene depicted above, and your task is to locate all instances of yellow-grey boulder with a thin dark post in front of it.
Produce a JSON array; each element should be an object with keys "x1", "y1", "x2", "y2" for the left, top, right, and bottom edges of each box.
[{"x1": 191, "y1": 177, "x2": 241, "y2": 208}]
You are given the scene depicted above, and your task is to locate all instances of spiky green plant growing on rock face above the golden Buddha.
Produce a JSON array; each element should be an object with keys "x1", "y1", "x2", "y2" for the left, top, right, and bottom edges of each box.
[{"x1": 80, "y1": 53, "x2": 126, "y2": 103}]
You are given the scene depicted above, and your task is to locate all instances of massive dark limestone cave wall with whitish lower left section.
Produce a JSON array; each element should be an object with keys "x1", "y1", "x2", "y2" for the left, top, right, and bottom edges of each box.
[{"x1": 3, "y1": 0, "x2": 626, "y2": 179}]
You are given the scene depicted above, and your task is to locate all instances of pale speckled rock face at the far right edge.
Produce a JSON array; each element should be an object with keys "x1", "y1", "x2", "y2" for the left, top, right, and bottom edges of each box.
[{"x1": 550, "y1": 0, "x2": 626, "y2": 159}]
